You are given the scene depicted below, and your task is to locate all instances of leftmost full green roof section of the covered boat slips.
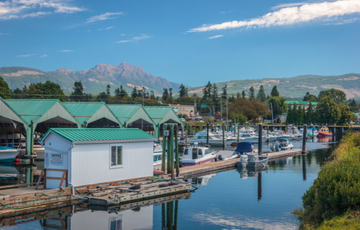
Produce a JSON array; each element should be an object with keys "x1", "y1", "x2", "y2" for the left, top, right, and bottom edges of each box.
[{"x1": 5, "y1": 99, "x2": 59, "y2": 116}]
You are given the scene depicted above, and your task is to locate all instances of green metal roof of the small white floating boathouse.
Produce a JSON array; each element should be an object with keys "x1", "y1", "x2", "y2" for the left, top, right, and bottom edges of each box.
[{"x1": 41, "y1": 128, "x2": 154, "y2": 142}]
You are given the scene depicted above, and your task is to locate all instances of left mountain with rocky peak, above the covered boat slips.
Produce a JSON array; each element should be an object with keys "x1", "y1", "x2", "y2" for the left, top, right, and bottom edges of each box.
[{"x1": 0, "y1": 63, "x2": 180, "y2": 94}]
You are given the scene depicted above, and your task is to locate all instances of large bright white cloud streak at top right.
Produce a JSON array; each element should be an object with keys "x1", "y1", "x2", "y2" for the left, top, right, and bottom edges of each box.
[{"x1": 188, "y1": 0, "x2": 360, "y2": 32}]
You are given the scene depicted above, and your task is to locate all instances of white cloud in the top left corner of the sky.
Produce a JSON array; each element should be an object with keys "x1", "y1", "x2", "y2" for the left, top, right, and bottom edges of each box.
[{"x1": 0, "y1": 0, "x2": 85, "y2": 20}]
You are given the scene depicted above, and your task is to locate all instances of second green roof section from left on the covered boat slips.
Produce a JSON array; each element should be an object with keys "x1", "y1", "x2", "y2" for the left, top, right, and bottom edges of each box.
[{"x1": 62, "y1": 102, "x2": 105, "y2": 124}]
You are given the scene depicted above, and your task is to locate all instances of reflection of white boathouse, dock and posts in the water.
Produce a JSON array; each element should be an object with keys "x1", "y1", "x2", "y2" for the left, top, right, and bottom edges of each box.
[{"x1": 0, "y1": 192, "x2": 191, "y2": 230}]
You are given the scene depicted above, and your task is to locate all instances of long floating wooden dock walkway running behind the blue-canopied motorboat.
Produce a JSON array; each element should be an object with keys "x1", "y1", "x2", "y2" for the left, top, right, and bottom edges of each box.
[{"x1": 179, "y1": 149, "x2": 309, "y2": 178}]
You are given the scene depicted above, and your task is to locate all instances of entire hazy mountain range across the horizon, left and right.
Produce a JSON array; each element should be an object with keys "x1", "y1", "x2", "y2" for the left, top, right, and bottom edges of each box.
[{"x1": 0, "y1": 63, "x2": 360, "y2": 99}]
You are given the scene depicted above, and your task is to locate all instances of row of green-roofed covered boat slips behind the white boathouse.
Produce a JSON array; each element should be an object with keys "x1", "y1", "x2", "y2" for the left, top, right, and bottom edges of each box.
[{"x1": 0, "y1": 97, "x2": 183, "y2": 155}]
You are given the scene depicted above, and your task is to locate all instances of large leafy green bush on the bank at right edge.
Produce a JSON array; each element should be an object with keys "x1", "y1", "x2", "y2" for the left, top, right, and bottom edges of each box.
[{"x1": 300, "y1": 133, "x2": 360, "y2": 226}]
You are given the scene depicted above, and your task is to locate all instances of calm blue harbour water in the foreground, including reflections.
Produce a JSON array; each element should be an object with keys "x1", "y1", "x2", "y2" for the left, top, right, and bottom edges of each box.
[{"x1": 0, "y1": 137, "x2": 335, "y2": 230}]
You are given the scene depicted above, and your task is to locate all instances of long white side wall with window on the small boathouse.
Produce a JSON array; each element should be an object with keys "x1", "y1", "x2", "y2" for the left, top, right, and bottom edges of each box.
[{"x1": 71, "y1": 141, "x2": 153, "y2": 186}]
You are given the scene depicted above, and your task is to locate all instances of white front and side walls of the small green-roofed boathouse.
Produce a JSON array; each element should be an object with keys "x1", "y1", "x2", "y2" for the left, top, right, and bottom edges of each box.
[{"x1": 44, "y1": 133, "x2": 153, "y2": 188}]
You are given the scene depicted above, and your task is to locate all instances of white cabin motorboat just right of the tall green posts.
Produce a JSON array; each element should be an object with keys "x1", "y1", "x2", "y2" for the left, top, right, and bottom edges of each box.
[{"x1": 180, "y1": 146, "x2": 217, "y2": 166}]
